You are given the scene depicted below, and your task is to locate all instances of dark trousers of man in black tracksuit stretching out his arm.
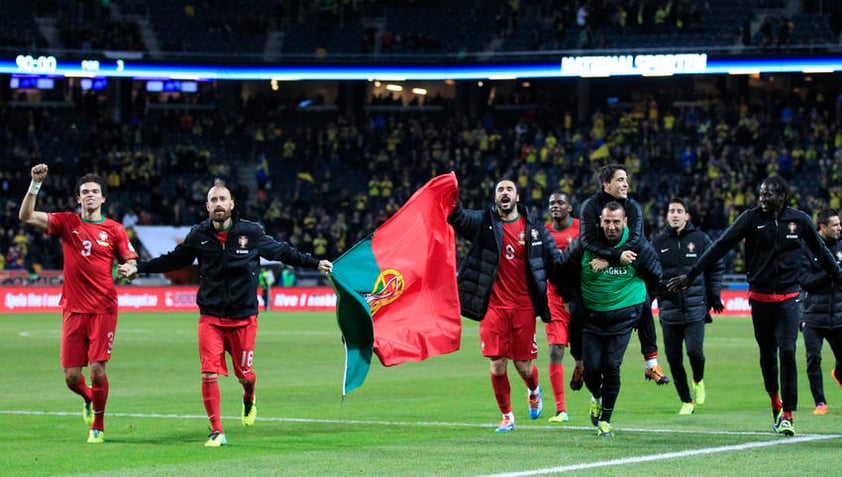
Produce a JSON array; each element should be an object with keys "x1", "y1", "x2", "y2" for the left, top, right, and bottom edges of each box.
[{"x1": 749, "y1": 298, "x2": 801, "y2": 412}]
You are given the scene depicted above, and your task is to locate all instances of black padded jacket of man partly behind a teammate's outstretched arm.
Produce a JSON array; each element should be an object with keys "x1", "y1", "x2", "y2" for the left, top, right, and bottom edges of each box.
[{"x1": 652, "y1": 223, "x2": 725, "y2": 323}]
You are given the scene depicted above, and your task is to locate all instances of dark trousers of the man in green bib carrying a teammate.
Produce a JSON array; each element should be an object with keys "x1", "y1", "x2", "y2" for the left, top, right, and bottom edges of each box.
[{"x1": 582, "y1": 305, "x2": 643, "y2": 422}]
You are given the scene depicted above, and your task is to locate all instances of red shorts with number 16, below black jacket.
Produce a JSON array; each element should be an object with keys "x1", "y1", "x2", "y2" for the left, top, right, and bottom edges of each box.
[{"x1": 199, "y1": 315, "x2": 257, "y2": 379}]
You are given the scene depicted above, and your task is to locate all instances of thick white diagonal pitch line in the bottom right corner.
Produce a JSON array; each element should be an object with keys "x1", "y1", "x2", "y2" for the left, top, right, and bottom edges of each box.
[{"x1": 482, "y1": 434, "x2": 842, "y2": 477}]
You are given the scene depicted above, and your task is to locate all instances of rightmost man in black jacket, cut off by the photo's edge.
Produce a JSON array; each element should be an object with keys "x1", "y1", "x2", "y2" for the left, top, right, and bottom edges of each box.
[{"x1": 801, "y1": 209, "x2": 842, "y2": 415}]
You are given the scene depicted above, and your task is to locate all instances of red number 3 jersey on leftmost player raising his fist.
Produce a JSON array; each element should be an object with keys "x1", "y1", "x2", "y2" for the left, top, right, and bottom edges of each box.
[{"x1": 44, "y1": 212, "x2": 137, "y2": 313}]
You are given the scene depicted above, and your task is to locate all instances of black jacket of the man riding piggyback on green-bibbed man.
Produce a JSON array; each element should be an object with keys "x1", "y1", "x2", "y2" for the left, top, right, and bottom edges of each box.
[{"x1": 579, "y1": 191, "x2": 644, "y2": 265}]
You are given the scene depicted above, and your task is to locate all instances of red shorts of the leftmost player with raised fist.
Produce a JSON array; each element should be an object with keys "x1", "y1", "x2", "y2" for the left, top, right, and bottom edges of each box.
[{"x1": 61, "y1": 311, "x2": 117, "y2": 368}]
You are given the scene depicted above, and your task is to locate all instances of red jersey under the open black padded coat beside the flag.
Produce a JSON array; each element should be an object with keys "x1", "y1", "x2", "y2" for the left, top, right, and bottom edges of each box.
[{"x1": 489, "y1": 217, "x2": 532, "y2": 308}]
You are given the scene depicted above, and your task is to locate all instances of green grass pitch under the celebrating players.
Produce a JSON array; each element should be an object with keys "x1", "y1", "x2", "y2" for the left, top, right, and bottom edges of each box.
[{"x1": 0, "y1": 312, "x2": 842, "y2": 477}]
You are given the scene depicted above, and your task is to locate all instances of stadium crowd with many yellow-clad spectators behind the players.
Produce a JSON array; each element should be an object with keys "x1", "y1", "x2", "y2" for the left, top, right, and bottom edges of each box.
[{"x1": 0, "y1": 75, "x2": 842, "y2": 273}]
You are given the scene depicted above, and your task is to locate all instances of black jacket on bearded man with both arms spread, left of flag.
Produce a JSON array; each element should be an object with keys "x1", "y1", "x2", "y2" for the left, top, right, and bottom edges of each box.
[{"x1": 137, "y1": 217, "x2": 319, "y2": 319}]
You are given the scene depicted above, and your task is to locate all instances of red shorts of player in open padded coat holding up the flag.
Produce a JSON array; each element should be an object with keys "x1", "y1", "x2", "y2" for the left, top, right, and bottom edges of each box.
[{"x1": 479, "y1": 306, "x2": 538, "y2": 361}]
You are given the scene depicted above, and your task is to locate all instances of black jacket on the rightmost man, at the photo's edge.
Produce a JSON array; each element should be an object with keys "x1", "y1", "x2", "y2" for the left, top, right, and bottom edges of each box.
[{"x1": 801, "y1": 235, "x2": 842, "y2": 330}]
